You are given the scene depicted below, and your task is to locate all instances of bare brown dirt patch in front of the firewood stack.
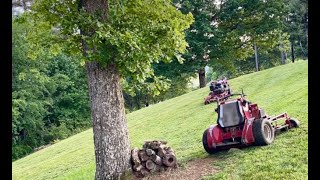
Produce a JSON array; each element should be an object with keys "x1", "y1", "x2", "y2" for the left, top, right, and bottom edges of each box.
[{"x1": 132, "y1": 157, "x2": 217, "y2": 180}]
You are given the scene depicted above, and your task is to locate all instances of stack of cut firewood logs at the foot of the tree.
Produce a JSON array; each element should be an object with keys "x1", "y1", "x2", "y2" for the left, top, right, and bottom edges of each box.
[{"x1": 131, "y1": 140, "x2": 177, "y2": 177}]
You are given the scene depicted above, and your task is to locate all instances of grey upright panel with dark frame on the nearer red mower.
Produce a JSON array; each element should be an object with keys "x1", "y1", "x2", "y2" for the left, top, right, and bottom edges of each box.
[{"x1": 217, "y1": 100, "x2": 244, "y2": 128}]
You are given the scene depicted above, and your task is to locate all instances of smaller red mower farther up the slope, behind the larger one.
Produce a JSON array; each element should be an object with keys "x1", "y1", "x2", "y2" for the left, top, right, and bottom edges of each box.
[{"x1": 204, "y1": 78, "x2": 231, "y2": 105}]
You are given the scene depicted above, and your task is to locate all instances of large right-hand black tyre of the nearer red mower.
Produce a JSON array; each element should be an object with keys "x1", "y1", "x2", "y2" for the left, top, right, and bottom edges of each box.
[{"x1": 252, "y1": 119, "x2": 274, "y2": 146}]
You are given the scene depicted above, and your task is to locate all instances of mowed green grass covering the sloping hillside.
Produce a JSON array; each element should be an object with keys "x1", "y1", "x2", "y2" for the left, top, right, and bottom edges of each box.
[{"x1": 12, "y1": 61, "x2": 308, "y2": 180}]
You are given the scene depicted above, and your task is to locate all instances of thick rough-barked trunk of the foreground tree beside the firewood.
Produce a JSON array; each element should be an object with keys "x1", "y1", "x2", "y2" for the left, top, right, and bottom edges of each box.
[{"x1": 86, "y1": 62, "x2": 130, "y2": 180}]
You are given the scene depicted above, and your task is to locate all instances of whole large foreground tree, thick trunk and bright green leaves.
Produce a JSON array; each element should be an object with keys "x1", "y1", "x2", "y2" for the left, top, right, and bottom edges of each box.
[{"x1": 30, "y1": 0, "x2": 193, "y2": 179}]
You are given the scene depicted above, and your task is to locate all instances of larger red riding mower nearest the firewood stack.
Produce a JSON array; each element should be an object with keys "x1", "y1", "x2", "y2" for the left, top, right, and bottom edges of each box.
[{"x1": 202, "y1": 92, "x2": 300, "y2": 154}]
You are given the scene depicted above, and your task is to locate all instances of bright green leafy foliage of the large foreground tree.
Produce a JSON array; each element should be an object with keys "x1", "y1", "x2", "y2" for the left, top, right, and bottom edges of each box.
[{"x1": 32, "y1": 0, "x2": 193, "y2": 93}]
